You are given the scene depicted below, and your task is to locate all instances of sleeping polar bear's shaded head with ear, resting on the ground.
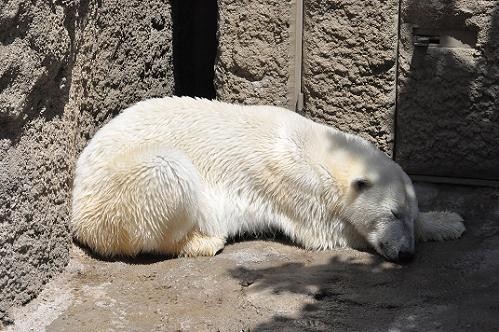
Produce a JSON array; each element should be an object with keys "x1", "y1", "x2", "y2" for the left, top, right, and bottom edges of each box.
[{"x1": 346, "y1": 162, "x2": 418, "y2": 261}]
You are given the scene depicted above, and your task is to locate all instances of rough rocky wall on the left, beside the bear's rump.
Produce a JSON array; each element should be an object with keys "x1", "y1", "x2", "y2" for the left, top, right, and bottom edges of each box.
[{"x1": 0, "y1": 0, "x2": 173, "y2": 325}]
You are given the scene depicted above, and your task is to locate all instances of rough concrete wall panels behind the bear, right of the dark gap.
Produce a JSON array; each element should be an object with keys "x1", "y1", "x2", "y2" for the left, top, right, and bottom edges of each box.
[{"x1": 215, "y1": 0, "x2": 499, "y2": 176}]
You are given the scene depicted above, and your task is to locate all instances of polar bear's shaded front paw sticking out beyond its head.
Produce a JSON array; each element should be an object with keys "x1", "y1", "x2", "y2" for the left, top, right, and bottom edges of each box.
[{"x1": 414, "y1": 211, "x2": 466, "y2": 241}]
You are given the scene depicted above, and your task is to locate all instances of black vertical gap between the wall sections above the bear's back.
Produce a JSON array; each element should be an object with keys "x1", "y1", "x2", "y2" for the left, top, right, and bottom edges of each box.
[{"x1": 171, "y1": 0, "x2": 218, "y2": 99}]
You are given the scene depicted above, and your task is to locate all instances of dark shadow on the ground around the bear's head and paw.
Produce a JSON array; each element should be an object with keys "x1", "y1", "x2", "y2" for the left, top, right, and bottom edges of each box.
[{"x1": 231, "y1": 185, "x2": 499, "y2": 331}]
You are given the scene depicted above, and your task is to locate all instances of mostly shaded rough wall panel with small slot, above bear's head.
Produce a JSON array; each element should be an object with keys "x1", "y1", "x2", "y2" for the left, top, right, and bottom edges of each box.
[{"x1": 396, "y1": 0, "x2": 499, "y2": 179}]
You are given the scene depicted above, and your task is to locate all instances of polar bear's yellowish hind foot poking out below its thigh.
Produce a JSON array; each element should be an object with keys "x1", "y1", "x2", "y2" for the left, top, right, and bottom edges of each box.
[{"x1": 178, "y1": 231, "x2": 225, "y2": 257}]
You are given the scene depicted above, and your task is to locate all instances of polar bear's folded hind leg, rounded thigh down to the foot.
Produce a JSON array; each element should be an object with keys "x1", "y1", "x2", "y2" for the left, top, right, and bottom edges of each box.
[{"x1": 73, "y1": 146, "x2": 224, "y2": 257}]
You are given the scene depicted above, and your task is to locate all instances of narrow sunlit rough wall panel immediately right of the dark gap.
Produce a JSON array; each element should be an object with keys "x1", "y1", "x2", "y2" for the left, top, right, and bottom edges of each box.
[{"x1": 215, "y1": 0, "x2": 294, "y2": 107}]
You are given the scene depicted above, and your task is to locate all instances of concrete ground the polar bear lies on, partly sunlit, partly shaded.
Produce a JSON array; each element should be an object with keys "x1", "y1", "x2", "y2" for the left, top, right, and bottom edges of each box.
[{"x1": 7, "y1": 184, "x2": 499, "y2": 332}]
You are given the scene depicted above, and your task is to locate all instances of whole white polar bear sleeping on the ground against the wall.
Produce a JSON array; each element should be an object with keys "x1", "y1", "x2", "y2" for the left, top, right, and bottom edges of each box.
[{"x1": 71, "y1": 97, "x2": 465, "y2": 261}]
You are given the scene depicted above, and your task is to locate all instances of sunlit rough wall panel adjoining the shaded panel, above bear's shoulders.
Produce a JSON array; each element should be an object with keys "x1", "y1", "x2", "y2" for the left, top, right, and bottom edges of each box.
[{"x1": 303, "y1": 0, "x2": 398, "y2": 154}]
